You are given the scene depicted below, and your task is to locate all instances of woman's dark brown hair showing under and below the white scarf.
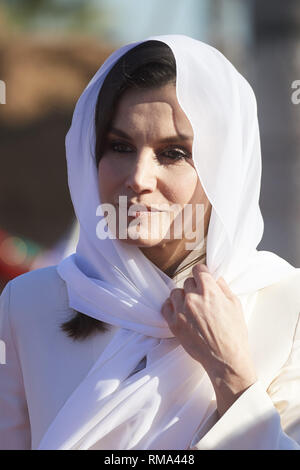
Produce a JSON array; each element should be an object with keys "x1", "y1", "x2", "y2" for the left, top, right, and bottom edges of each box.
[{"x1": 61, "y1": 41, "x2": 176, "y2": 339}]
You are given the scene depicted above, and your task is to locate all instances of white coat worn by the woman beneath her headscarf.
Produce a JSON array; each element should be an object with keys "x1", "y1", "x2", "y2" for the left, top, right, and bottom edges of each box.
[{"x1": 0, "y1": 266, "x2": 300, "y2": 450}]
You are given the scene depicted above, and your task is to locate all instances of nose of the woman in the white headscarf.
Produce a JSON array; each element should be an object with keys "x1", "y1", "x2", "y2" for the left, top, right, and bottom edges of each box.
[{"x1": 126, "y1": 148, "x2": 156, "y2": 193}]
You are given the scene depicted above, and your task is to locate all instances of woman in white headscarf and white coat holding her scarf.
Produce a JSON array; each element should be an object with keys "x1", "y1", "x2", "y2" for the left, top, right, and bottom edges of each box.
[{"x1": 0, "y1": 35, "x2": 300, "y2": 450}]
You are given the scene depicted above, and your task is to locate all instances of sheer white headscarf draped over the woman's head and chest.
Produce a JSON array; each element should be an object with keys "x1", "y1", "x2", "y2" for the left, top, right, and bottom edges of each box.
[{"x1": 39, "y1": 35, "x2": 295, "y2": 450}]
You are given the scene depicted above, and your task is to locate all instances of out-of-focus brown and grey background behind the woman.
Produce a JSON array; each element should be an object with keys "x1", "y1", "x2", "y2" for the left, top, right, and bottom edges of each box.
[{"x1": 0, "y1": 0, "x2": 300, "y2": 290}]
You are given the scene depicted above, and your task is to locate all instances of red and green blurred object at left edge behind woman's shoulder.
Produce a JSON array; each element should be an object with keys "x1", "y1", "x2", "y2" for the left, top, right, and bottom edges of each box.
[{"x1": 0, "y1": 229, "x2": 43, "y2": 283}]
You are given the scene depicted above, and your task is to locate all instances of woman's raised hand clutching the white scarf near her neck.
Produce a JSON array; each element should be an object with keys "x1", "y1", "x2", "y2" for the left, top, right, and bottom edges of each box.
[{"x1": 161, "y1": 263, "x2": 257, "y2": 415}]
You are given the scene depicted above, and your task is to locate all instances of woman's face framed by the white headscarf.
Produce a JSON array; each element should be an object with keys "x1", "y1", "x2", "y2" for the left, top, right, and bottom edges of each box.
[{"x1": 98, "y1": 84, "x2": 210, "y2": 270}]
